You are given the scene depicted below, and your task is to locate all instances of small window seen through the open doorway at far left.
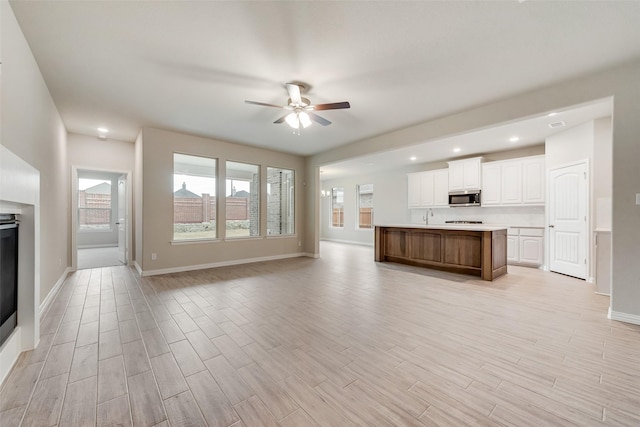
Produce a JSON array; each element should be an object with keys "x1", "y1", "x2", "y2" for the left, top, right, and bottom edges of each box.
[{"x1": 78, "y1": 178, "x2": 111, "y2": 231}]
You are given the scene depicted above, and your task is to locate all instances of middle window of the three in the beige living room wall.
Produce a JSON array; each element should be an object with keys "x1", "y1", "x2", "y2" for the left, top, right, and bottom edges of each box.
[{"x1": 225, "y1": 162, "x2": 260, "y2": 237}]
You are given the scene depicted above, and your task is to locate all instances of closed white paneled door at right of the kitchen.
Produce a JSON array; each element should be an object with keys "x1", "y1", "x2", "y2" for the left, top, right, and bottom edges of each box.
[{"x1": 549, "y1": 163, "x2": 588, "y2": 279}]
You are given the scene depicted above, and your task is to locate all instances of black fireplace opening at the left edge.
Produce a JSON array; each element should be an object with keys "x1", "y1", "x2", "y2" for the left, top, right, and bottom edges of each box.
[{"x1": 0, "y1": 214, "x2": 18, "y2": 346}]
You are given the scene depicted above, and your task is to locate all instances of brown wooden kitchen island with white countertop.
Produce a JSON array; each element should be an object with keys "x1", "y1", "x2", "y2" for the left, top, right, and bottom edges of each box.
[{"x1": 375, "y1": 224, "x2": 507, "y2": 280}]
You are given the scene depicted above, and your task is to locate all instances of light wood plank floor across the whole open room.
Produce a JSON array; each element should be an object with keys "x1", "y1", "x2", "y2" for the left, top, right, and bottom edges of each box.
[{"x1": 0, "y1": 242, "x2": 640, "y2": 427}]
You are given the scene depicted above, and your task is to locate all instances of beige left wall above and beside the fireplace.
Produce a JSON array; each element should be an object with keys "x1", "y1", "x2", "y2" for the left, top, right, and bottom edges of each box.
[{"x1": 0, "y1": 1, "x2": 70, "y2": 301}]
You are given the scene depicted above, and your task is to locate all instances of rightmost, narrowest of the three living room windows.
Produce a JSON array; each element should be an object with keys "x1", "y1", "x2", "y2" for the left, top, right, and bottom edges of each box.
[{"x1": 267, "y1": 168, "x2": 295, "y2": 235}]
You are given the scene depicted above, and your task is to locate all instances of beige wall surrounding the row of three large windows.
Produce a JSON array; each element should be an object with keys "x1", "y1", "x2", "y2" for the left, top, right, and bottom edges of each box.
[{"x1": 136, "y1": 128, "x2": 305, "y2": 272}]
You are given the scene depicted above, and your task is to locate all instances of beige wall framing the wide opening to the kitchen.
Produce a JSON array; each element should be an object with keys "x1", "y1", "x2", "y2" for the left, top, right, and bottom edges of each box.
[{"x1": 305, "y1": 61, "x2": 640, "y2": 323}]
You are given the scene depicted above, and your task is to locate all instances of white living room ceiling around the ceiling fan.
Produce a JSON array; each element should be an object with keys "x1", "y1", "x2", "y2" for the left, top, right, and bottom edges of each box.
[{"x1": 11, "y1": 0, "x2": 640, "y2": 155}]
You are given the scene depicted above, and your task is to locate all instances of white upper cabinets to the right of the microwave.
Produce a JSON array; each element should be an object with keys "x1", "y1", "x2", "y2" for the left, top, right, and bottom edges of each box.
[{"x1": 482, "y1": 156, "x2": 545, "y2": 206}]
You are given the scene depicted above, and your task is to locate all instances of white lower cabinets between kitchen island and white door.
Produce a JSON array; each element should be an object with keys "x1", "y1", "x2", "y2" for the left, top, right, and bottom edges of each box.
[{"x1": 507, "y1": 227, "x2": 544, "y2": 266}]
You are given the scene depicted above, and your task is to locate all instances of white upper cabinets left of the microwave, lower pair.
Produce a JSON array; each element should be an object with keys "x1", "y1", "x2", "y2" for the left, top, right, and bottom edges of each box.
[{"x1": 407, "y1": 169, "x2": 449, "y2": 208}]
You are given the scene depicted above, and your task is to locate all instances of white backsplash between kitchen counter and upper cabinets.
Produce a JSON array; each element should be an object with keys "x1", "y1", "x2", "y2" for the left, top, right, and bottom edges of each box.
[{"x1": 410, "y1": 206, "x2": 545, "y2": 227}]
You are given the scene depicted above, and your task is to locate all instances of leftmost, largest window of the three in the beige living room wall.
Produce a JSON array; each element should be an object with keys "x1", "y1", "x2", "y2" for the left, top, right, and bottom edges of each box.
[{"x1": 173, "y1": 153, "x2": 217, "y2": 240}]
